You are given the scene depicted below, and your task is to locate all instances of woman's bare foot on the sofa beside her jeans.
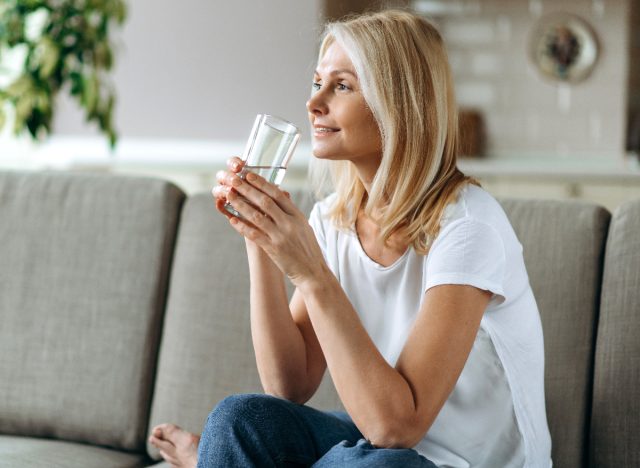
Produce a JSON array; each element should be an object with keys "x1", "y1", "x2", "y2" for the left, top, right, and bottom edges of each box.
[{"x1": 149, "y1": 424, "x2": 200, "y2": 468}]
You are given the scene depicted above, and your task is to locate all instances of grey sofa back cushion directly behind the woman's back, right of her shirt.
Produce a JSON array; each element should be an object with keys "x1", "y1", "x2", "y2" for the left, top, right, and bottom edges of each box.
[{"x1": 501, "y1": 200, "x2": 610, "y2": 467}]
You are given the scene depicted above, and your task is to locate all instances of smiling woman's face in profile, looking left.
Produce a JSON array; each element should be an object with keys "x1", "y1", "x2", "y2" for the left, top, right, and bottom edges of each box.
[{"x1": 307, "y1": 42, "x2": 382, "y2": 173}]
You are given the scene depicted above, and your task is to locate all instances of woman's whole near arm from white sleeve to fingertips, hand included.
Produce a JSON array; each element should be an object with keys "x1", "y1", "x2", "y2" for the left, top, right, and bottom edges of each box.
[{"x1": 229, "y1": 170, "x2": 491, "y2": 447}]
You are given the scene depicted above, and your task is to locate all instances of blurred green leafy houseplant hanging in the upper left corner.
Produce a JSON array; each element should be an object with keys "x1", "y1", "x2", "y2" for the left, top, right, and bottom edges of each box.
[{"x1": 0, "y1": 0, "x2": 126, "y2": 148}]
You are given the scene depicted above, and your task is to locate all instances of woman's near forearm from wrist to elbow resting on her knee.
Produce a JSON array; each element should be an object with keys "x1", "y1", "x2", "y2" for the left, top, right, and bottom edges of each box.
[{"x1": 298, "y1": 271, "x2": 416, "y2": 446}]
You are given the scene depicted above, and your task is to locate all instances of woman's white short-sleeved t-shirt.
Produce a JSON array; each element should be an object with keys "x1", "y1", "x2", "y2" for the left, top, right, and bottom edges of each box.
[{"x1": 309, "y1": 185, "x2": 551, "y2": 468}]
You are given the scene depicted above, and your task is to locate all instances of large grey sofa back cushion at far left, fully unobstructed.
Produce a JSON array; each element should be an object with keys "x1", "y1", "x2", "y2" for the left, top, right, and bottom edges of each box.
[{"x1": 0, "y1": 172, "x2": 184, "y2": 452}]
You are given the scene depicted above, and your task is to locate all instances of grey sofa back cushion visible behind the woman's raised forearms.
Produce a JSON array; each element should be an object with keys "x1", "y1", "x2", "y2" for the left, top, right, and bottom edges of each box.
[{"x1": 149, "y1": 193, "x2": 340, "y2": 457}]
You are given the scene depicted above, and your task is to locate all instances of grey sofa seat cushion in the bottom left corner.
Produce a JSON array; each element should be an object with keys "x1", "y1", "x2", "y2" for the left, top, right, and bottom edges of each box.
[{"x1": 0, "y1": 436, "x2": 151, "y2": 468}]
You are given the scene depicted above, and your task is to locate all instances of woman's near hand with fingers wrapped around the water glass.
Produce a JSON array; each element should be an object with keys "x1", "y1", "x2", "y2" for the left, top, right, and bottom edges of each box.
[{"x1": 222, "y1": 168, "x2": 324, "y2": 286}]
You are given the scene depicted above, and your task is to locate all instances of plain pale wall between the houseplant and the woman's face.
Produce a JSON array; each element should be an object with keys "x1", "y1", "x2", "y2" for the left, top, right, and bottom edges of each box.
[{"x1": 54, "y1": 0, "x2": 321, "y2": 141}]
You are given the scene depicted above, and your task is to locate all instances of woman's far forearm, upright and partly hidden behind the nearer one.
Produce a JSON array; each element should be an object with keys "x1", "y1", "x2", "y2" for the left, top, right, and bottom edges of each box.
[{"x1": 247, "y1": 241, "x2": 307, "y2": 401}]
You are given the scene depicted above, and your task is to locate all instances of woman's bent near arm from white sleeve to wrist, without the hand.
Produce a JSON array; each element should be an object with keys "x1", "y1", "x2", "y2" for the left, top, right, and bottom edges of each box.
[{"x1": 299, "y1": 275, "x2": 491, "y2": 447}]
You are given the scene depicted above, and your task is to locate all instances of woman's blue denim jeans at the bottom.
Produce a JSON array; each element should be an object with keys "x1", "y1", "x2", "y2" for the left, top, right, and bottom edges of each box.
[{"x1": 198, "y1": 395, "x2": 436, "y2": 468}]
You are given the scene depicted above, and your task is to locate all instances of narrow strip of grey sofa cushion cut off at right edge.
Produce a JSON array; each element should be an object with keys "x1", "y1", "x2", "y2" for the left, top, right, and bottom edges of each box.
[{"x1": 590, "y1": 200, "x2": 640, "y2": 468}]
